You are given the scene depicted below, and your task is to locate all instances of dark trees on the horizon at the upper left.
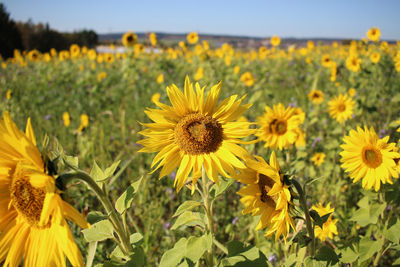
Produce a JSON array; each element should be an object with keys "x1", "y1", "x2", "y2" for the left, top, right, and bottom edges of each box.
[{"x1": 0, "y1": 3, "x2": 98, "y2": 58}]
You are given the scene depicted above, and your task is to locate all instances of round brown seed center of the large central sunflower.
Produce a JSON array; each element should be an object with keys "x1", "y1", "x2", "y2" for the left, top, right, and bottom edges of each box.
[{"x1": 175, "y1": 113, "x2": 223, "y2": 155}]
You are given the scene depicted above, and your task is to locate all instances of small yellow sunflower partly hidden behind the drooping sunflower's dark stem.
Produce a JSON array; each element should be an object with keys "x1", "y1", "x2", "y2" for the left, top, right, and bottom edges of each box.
[{"x1": 312, "y1": 203, "x2": 338, "y2": 242}]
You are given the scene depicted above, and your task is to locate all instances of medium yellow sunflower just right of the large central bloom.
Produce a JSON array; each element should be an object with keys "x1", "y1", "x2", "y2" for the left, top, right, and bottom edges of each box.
[{"x1": 256, "y1": 103, "x2": 305, "y2": 150}]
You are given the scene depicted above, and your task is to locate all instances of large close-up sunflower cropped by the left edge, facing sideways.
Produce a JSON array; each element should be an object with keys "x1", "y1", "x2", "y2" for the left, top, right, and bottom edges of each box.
[{"x1": 0, "y1": 112, "x2": 88, "y2": 266}]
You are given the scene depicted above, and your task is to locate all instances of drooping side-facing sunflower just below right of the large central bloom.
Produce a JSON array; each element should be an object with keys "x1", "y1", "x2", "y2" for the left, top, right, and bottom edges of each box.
[{"x1": 235, "y1": 152, "x2": 294, "y2": 241}]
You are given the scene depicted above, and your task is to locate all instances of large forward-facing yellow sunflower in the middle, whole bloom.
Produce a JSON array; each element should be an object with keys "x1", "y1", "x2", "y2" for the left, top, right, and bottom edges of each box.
[{"x1": 138, "y1": 77, "x2": 254, "y2": 191}]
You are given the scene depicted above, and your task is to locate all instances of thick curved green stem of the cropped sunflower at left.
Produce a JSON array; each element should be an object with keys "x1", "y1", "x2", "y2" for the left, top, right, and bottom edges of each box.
[{"x1": 58, "y1": 170, "x2": 132, "y2": 256}]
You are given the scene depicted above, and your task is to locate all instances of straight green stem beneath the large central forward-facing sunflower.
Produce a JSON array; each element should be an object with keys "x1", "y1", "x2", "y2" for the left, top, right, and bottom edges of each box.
[{"x1": 201, "y1": 166, "x2": 215, "y2": 266}]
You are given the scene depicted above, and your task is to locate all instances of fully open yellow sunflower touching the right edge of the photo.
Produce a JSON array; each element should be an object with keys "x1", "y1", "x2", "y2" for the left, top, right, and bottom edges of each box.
[{"x1": 340, "y1": 127, "x2": 400, "y2": 191}]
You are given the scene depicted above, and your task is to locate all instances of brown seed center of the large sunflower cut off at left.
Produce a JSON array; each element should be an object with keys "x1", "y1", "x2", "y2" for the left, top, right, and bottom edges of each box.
[{"x1": 10, "y1": 164, "x2": 46, "y2": 225}]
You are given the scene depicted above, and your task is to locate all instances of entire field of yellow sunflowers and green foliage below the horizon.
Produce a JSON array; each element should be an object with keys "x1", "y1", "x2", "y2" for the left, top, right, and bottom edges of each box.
[{"x1": 0, "y1": 28, "x2": 400, "y2": 267}]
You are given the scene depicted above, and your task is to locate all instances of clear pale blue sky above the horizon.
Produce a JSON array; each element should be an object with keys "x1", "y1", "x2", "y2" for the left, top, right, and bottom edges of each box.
[{"x1": 1, "y1": 0, "x2": 400, "y2": 40}]
